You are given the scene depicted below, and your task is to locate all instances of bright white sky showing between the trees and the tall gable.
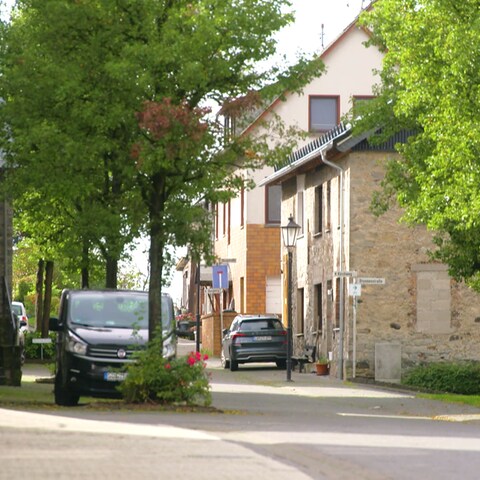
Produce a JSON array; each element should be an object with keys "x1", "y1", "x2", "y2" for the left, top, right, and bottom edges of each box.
[{"x1": 0, "y1": 0, "x2": 370, "y2": 302}]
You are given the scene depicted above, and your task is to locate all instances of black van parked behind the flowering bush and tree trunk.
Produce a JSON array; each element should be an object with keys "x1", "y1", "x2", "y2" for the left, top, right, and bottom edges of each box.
[{"x1": 50, "y1": 290, "x2": 177, "y2": 406}]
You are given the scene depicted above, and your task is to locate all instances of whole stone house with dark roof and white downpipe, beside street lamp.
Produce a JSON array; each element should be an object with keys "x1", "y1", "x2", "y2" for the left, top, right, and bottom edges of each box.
[{"x1": 263, "y1": 125, "x2": 480, "y2": 381}]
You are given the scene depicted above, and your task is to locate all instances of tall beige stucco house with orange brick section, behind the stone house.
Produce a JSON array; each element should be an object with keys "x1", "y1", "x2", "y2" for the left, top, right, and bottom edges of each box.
[{"x1": 215, "y1": 19, "x2": 382, "y2": 315}]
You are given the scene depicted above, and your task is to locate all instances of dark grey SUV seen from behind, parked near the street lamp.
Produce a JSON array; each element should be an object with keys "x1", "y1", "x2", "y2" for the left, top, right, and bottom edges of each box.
[{"x1": 221, "y1": 315, "x2": 287, "y2": 372}]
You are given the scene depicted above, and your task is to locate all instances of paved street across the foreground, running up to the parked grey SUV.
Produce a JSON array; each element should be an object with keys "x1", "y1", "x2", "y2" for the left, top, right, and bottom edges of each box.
[{"x1": 0, "y1": 340, "x2": 480, "y2": 480}]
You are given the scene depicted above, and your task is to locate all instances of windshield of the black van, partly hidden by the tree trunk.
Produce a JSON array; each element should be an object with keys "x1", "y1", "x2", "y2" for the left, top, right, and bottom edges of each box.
[{"x1": 68, "y1": 291, "x2": 173, "y2": 330}]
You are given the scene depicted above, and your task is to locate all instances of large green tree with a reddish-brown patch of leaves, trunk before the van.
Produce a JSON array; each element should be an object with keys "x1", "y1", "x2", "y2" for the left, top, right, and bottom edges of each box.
[{"x1": 0, "y1": 0, "x2": 322, "y2": 337}]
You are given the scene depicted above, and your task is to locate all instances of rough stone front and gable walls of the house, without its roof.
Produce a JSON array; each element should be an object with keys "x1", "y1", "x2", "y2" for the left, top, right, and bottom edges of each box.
[{"x1": 282, "y1": 151, "x2": 480, "y2": 376}]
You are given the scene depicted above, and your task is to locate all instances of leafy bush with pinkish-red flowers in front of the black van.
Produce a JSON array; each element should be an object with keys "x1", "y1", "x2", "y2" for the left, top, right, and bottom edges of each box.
[{"x1": 118, "y1": 334, "x2": 212, "y2": 406}]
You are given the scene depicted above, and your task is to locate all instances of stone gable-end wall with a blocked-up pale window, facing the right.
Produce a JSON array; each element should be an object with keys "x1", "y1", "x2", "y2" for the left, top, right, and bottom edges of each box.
[{"x1": 348, "y1": 152, "x2": 480, "y2": 373}]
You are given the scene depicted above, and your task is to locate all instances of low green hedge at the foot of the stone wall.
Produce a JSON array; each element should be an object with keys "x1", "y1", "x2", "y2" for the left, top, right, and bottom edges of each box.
[{"x1": 402, "y1": 362, "x2": 480, "y2": 395}]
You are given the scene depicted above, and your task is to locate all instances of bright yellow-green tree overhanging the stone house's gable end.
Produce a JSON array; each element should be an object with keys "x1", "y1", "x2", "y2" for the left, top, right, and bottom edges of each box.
[{"x1": 356, "y1": 0, "x2": 480, "y2": 290}]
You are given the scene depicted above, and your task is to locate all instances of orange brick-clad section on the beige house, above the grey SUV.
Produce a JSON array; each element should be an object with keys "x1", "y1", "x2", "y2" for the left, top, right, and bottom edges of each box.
[{"x1": 245, "y1": 225, "x2": 281, "y2": 313}]
